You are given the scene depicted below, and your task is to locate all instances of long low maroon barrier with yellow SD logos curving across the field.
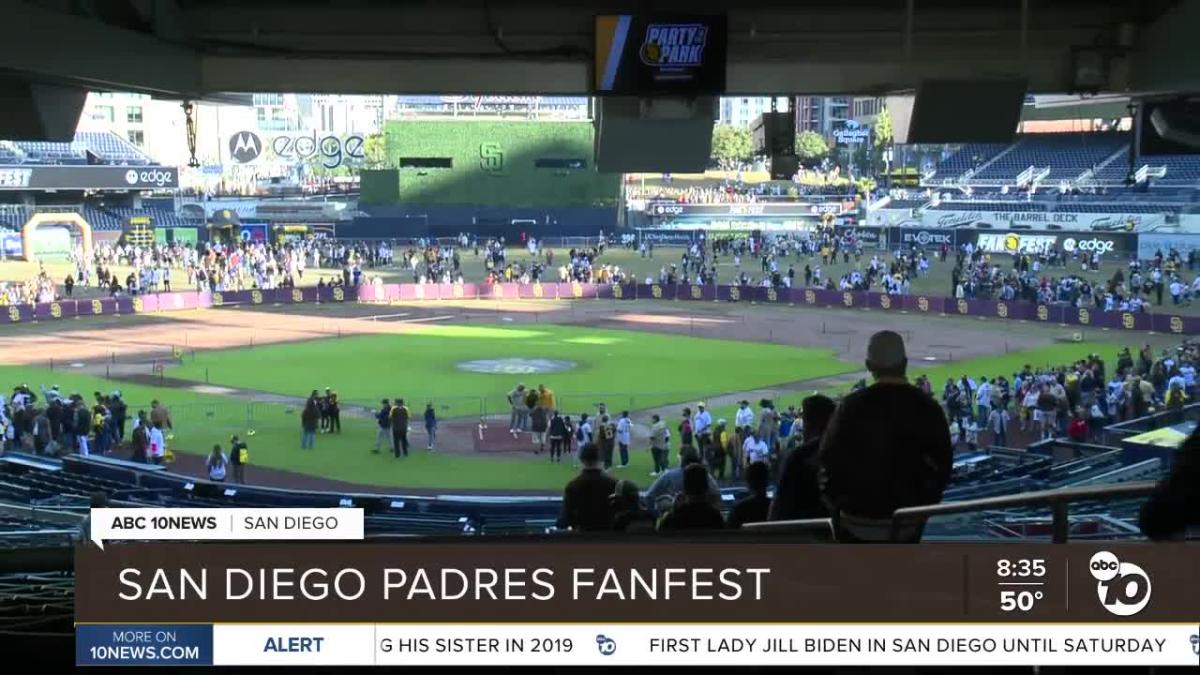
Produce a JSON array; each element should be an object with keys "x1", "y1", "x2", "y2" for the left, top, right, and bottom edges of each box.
[{"x1": 0, "y1": 283, "x2": 1200, "y2": 335}]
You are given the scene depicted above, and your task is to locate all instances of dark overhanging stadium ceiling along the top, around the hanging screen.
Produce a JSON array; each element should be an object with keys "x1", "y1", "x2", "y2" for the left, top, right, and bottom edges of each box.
[{"x1": 0, "y1": 0, "x2": 1200, "y2": 99}]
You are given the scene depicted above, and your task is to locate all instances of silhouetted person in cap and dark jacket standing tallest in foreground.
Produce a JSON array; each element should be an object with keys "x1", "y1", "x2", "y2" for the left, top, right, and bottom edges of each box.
[{"x1": 820, "y1": 330, "x2": 953, "y2": 542}]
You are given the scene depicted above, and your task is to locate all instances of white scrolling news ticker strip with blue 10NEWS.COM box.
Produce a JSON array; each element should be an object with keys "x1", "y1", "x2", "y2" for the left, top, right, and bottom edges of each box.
[{"x1": 76, "y1": 623, "x2": 1200, "y2": 667}]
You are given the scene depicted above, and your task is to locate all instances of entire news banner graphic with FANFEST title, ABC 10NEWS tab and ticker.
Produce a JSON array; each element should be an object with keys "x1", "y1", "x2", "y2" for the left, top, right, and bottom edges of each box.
[{"x1": 76, "y1": 508, "x2": 1200, "y2": 667}]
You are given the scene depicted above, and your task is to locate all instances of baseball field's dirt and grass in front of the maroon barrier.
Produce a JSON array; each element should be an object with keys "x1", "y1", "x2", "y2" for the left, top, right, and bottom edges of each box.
[{"x1": 0, "y1": 273, "x2": 1170, "y2": 492}]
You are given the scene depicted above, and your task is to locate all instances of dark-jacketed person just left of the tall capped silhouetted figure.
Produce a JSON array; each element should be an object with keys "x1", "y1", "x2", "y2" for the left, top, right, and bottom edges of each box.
[{"x1": 769, "y1": 394, "x2": 836, "y2": 520}]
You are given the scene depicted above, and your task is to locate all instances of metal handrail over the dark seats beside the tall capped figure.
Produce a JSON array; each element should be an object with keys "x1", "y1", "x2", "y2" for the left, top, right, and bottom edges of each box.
[{"x1": 743, "y1": 480, "x2": 1157, "y2": 544}]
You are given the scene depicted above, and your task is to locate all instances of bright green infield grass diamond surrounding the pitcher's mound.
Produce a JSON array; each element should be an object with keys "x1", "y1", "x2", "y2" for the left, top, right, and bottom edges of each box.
[{"x1": 168, "y1": 324, "x2": 854, "y2": 417}]
